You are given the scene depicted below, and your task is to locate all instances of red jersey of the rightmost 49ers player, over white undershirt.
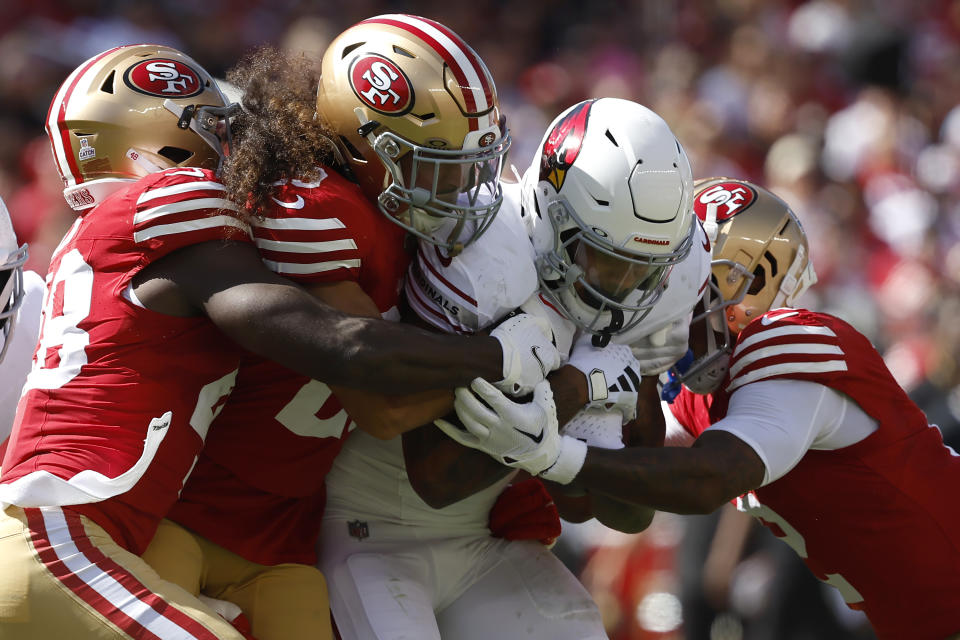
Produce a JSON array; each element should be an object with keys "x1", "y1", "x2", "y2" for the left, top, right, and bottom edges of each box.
[{"x1": 677, "y1": 309, "x2": 960, "y2": 638}]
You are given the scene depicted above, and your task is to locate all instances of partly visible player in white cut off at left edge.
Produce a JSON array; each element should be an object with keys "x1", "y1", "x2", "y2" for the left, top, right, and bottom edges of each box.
[{"x1": 0, "y1": 200, "x2": 44, "y2": 444}]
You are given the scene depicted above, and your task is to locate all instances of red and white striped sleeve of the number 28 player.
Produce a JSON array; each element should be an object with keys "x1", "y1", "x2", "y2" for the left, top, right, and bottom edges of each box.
[{"x1": 133, "y1": 168, "x2": 250, "y2": 259}]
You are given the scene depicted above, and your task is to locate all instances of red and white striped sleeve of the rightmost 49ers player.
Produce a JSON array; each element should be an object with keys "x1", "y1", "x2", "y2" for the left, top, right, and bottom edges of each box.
[{"x1": 726, "y1": 309, "x2": 848, "y2": 392}]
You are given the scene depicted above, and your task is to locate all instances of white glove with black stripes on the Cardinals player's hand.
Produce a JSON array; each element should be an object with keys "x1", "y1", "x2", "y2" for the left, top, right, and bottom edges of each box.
[{"x1": 567, "y1": 334, "x2": 640, "y2": 423}]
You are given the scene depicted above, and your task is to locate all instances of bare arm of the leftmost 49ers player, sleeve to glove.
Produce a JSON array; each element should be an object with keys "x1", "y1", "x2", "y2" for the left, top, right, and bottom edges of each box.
[{"x1": 153, "y1": 242, "x2": 504, "y2": 393}]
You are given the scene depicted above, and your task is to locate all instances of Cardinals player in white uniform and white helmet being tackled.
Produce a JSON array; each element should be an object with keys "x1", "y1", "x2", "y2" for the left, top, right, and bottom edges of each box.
[{"x1": 319, "y1": 99, "x2": 709, "y2": 640}]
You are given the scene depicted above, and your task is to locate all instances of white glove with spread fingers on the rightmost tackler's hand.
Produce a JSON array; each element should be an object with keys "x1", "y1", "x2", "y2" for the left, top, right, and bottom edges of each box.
[{"x1": 435, "y1": 378, "x2": 587, "y2": 484}]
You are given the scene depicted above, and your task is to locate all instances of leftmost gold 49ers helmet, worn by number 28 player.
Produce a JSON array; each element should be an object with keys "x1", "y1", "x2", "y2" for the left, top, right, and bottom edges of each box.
[{"x1": 46, "y1": 44, "x2": 231, "y2": 211}]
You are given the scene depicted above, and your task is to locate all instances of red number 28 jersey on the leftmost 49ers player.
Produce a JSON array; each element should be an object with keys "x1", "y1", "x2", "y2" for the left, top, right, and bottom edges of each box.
[{"x1": 0, "y1": 169, "x2": 251, "y2": 553}]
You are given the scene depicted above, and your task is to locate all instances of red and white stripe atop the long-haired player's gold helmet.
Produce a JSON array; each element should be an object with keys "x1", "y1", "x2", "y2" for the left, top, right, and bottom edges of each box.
[{"x1": 361, "y1": 14, "x2": 493, "y2": 131}]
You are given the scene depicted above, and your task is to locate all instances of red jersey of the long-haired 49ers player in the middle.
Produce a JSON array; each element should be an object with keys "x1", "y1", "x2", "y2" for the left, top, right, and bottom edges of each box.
[{"x1": 170, "y1": 171, "x2": 409, "y2": 564}]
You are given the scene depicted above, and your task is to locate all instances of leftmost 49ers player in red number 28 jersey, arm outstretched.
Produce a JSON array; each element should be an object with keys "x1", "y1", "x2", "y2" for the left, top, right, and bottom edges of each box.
[{"x1": 0, "y1": 45, "x2": 558, "y2": 638}]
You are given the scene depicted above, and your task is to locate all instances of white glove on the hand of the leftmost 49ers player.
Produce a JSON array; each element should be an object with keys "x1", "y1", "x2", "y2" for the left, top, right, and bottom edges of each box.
[{"x1": 490, "y1": 313, "x2": 560, "y2": 396}]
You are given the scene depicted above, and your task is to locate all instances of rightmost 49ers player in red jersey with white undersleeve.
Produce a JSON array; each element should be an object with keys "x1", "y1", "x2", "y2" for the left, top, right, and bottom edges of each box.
[{"x1": 442, "y1": 178, "x2": 960, "y2": 640}]
